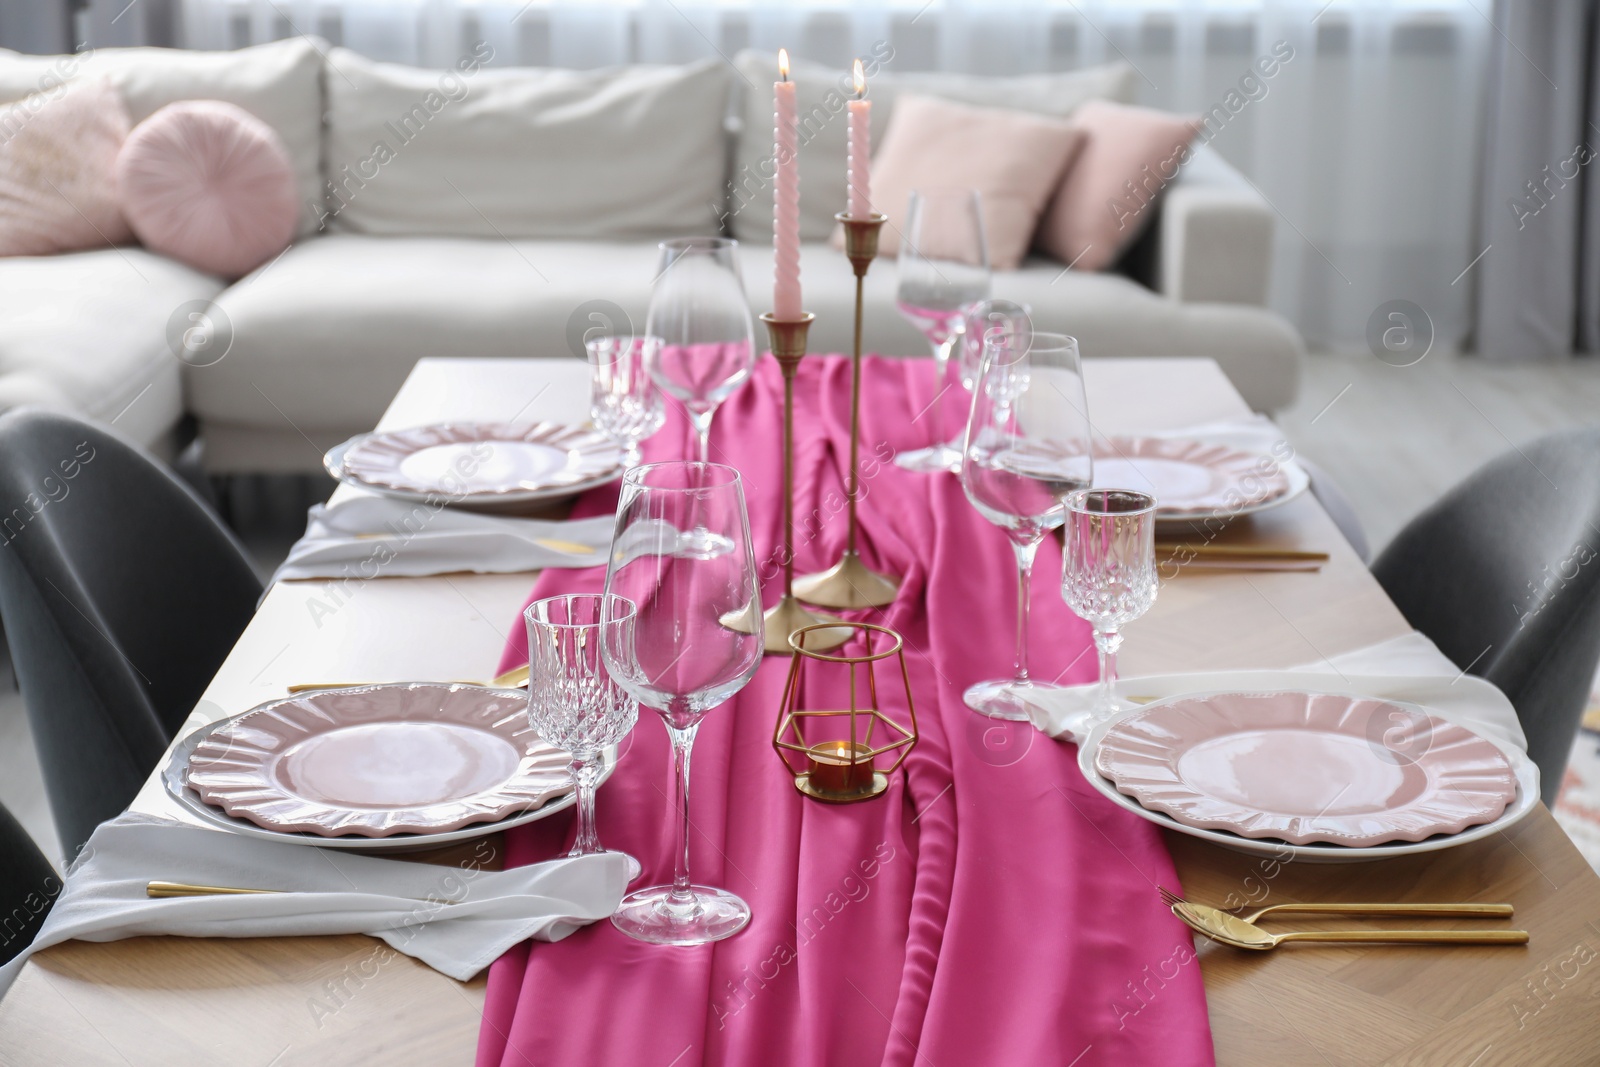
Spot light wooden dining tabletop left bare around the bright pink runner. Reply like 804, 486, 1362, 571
0, 358, 1600, 1067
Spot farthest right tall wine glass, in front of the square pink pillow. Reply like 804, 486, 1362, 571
894, 189, 989, 470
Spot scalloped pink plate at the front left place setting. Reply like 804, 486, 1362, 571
189, 681, 571, 837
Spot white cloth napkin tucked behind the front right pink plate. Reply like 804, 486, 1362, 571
1029, 630, 1528, 752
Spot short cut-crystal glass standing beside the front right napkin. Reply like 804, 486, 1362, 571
1061, 490, 1158, 737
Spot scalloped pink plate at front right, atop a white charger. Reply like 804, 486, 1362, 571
1096, 693, 1517, 846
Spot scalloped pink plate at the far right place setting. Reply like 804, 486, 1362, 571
1094, 437, 1290, 518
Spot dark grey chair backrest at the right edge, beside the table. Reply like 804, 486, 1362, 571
1373, 429, 1600, 805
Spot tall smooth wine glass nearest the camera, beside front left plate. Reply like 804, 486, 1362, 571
602, 462, 765, 945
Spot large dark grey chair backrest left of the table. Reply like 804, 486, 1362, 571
0, 410, 261, 857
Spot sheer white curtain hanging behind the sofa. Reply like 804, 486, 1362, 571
172, 0, 1493, 346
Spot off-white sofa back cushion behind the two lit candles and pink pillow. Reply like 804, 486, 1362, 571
726, 51, 1136, 245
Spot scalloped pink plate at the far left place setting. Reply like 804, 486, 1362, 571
342, 422, 622, 499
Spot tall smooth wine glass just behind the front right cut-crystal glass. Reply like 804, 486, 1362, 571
960, 329, 1094, 720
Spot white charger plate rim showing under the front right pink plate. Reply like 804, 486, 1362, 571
1078, 693, 1539, 864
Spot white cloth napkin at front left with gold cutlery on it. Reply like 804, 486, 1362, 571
0, 813, 638, 997
